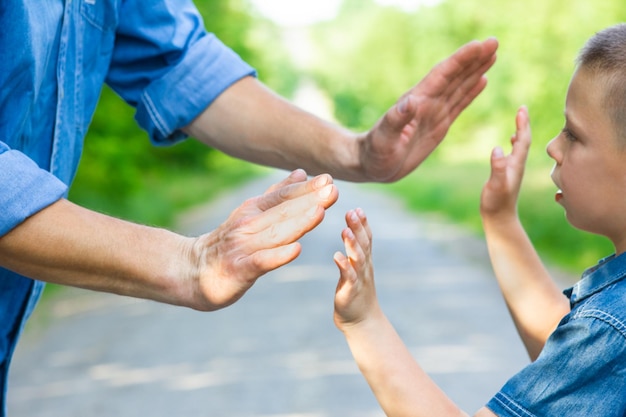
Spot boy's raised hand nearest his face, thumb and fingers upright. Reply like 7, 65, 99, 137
480, 107, 531, 220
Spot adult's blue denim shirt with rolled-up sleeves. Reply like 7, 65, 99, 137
0, 0, 256, 416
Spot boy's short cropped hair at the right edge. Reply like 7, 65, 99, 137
577, 23, 626, 146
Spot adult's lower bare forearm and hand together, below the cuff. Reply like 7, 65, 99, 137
0, 170, 338, 311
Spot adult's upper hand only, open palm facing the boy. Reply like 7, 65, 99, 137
359, 39, 498, 182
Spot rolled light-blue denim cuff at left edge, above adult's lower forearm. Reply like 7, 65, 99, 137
0, 142, 67, 237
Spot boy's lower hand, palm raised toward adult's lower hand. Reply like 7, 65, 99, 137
333, 209, 380, 331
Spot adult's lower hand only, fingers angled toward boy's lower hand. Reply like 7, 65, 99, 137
185, 170, 338, 310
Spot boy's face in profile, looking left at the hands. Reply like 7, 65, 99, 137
547, 68, 626, 253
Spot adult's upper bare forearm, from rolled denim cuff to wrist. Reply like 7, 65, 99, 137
185, 77, 364, 181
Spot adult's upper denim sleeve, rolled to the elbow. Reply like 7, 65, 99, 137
107, 0, 256, 144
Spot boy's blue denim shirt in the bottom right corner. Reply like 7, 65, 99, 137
487, 254, 626, 417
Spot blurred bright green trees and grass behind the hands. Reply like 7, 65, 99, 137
70, 0, 626, 273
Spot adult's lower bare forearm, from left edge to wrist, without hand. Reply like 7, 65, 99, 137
0, 200, 191, 305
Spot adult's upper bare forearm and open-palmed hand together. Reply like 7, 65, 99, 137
185, 39, 498, 182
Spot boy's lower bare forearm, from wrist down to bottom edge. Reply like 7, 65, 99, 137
343, 313, 467, 417
